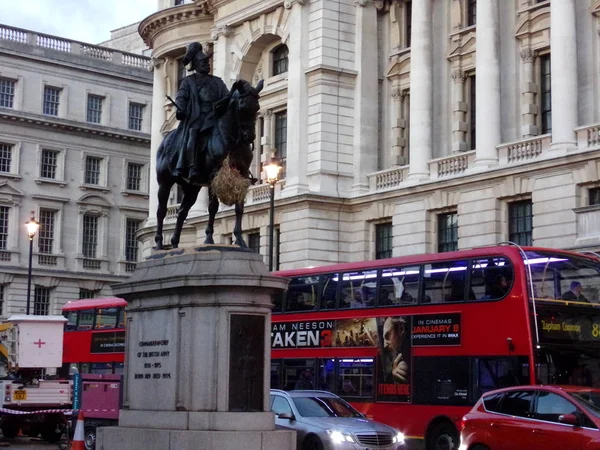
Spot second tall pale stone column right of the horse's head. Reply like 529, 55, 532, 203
352, 0, 379, 192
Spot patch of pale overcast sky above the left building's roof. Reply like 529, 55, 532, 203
0, 0, 157, 44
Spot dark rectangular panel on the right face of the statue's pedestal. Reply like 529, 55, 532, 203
229, 314, 265, 411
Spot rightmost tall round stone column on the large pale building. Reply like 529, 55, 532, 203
550, 0, 578, 151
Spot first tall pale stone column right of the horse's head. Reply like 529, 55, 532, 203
282, 0, 309, 196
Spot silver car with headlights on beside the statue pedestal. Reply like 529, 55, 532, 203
271, 389, 405, 450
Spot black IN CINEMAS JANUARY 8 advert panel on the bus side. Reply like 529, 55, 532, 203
412, 313, 461, 347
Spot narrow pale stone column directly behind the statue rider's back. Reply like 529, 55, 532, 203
146, 58, 167, 226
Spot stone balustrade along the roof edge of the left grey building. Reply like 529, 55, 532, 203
0, 25, 150, 69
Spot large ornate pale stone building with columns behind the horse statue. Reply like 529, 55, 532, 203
139, 0, 600, 269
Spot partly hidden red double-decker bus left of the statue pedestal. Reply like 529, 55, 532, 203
62, 297, 127, 376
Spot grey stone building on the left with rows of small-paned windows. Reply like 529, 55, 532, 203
0, 25, 152, 317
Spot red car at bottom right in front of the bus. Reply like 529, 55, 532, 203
459, 386, 600, 450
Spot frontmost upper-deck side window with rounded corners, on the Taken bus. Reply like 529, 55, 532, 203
471, 258, 514, 300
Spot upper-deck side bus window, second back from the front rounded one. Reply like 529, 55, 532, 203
423, 261, 471, 303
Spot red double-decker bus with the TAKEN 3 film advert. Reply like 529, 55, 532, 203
271, 244, 600, 450
